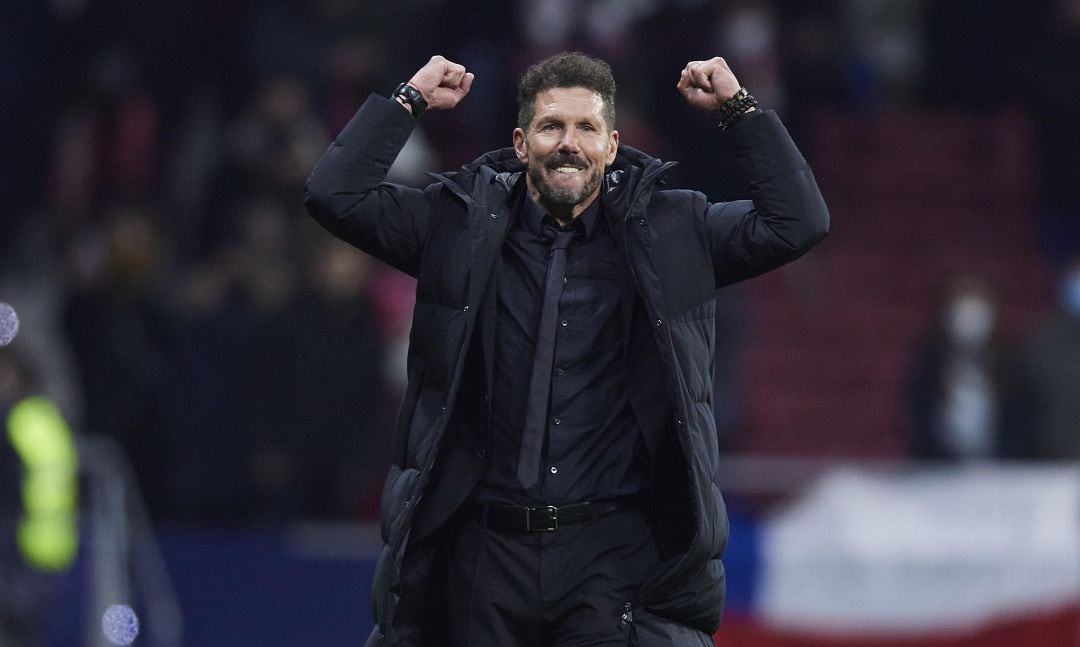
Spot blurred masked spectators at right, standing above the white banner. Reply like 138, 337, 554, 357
908, 265, 1080, 461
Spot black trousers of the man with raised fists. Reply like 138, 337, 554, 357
440, 510, 713, 647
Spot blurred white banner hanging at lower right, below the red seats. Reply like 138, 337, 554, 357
758, 464, 1080, 634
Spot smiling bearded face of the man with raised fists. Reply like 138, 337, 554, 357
514, 87, 619, 211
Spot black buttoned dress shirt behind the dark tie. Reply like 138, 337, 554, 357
476, 180, 646, 506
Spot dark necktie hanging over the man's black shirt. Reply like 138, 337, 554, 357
517, 225, 575, 489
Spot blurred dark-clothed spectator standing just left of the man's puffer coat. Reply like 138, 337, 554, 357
285, 233, 390, 520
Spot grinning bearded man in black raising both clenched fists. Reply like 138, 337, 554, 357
307, 54, 828, 647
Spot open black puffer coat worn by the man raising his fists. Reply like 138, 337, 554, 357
307, 97, 828, 645
